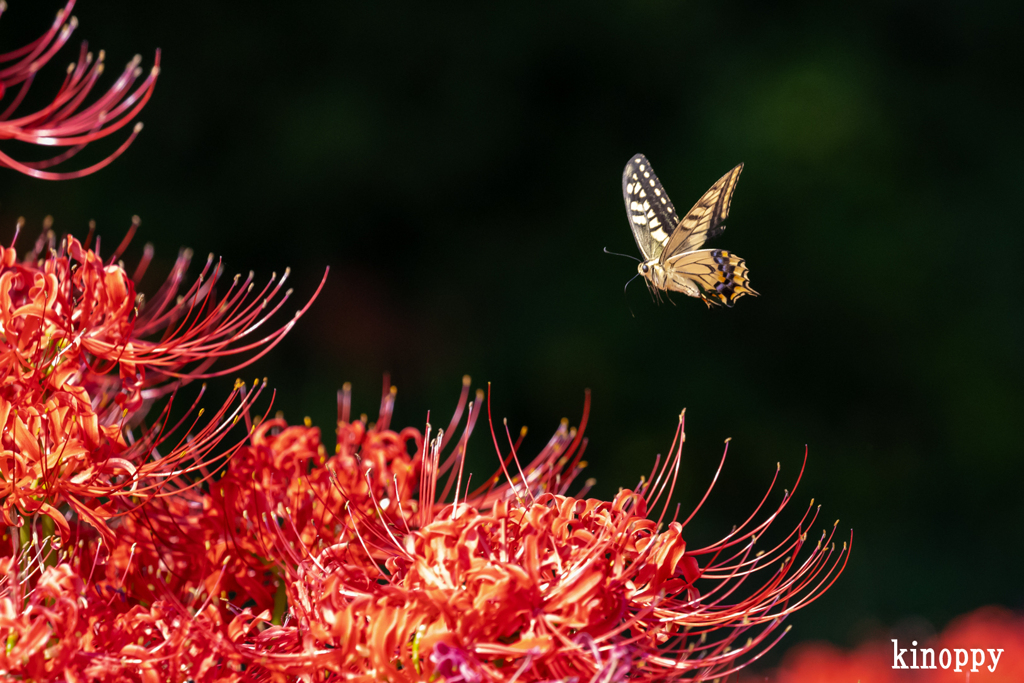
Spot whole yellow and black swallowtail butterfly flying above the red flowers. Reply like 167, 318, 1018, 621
623, 155, 758, 307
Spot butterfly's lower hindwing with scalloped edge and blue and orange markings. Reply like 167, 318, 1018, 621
665, 249, 758, 308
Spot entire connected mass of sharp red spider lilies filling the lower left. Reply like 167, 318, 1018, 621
0, 238, 848, 683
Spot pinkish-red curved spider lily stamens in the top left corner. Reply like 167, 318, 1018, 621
0, 0, 160, 180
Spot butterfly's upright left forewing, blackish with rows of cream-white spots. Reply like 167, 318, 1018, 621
623, 155, 679, 261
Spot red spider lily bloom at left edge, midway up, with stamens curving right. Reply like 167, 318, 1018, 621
0, 220, 323, 545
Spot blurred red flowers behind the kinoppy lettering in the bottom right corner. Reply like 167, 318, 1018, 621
739, 606, 1024, 683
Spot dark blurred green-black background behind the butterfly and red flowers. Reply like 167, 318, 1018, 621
0, 0, 1024, 663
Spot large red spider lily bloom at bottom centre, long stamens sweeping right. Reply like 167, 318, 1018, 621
263, 384, 847, 682
